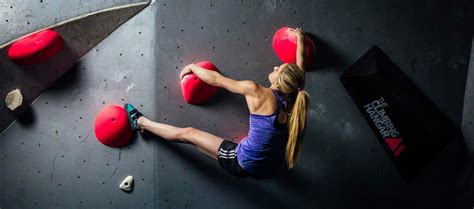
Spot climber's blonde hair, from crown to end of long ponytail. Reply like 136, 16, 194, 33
275, 64, 309, 168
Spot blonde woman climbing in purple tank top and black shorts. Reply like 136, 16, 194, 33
125, 28, 309, 178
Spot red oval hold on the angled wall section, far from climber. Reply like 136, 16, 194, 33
8, 29, 64, 65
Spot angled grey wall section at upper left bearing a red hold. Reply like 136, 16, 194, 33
0, 1, 148, 132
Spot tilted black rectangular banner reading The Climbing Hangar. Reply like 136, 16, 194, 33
340, 46, 462, 179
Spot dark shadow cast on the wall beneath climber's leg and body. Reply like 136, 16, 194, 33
143, 132, 314, 209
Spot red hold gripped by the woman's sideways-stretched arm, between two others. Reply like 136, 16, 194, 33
181, 61, 219, 104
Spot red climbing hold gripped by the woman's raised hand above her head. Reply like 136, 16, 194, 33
272, 27, 316, 66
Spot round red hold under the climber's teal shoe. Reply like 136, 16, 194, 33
95, 105, 133, 147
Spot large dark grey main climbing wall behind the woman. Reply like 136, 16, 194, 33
0, 0, 474, 209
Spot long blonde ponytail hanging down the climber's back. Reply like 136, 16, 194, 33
286, 90, 309, 168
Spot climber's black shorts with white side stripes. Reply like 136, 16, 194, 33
217, 140, 248, 177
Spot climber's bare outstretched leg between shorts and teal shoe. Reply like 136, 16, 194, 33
138, 116, 224, 160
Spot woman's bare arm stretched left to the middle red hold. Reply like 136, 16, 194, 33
180, 64, 260, 96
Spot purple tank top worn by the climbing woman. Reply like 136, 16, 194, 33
236, 89, 288, 178
